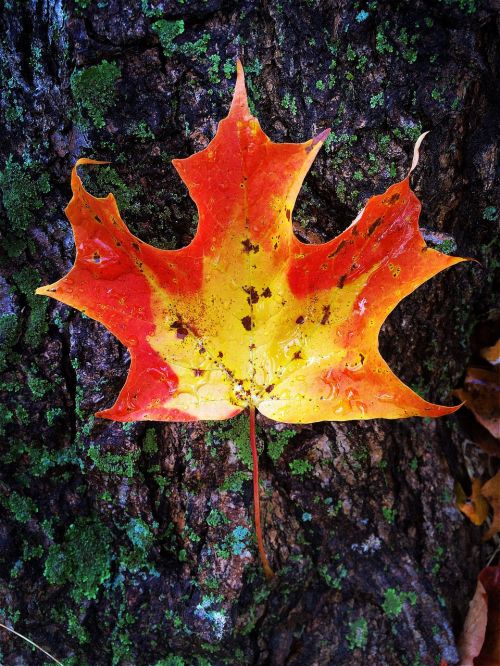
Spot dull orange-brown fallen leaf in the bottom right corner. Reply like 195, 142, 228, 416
458, 566, 500, 666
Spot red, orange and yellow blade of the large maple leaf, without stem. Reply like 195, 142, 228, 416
37, 63, 462, 423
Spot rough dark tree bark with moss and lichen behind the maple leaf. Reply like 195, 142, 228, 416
0, 0, 499, 666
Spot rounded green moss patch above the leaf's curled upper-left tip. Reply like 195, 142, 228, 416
70, 60, 121, 127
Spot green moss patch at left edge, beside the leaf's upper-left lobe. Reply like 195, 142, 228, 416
0, 155, 50, 257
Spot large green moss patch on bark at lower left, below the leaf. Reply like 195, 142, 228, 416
44, 517, 112, 602
